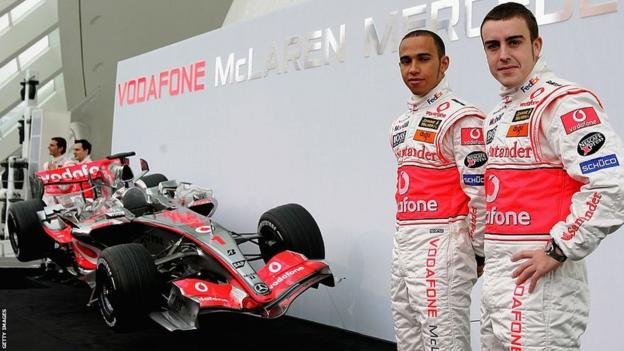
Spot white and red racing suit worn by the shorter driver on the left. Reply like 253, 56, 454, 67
390, 79, 486, 351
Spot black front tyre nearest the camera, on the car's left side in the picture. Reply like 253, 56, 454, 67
95, 244, 160, 332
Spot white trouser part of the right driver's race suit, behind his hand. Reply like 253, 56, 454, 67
481, 245, 589, 351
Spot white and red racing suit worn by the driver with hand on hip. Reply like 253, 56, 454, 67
481, 59, 624, 351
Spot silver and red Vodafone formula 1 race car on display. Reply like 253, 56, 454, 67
8, 152, 334, 331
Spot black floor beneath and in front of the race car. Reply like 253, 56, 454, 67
0, 268, 396, 351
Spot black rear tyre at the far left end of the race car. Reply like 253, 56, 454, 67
8, 199, 54, 262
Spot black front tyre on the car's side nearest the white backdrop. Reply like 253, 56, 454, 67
258, 204, 325, 262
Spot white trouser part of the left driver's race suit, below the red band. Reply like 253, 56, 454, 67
391, 220, 477, 351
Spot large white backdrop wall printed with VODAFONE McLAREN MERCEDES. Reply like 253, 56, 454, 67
112, 0, 624, 350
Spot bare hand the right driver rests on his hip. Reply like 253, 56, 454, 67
511, 249, 561, 293
